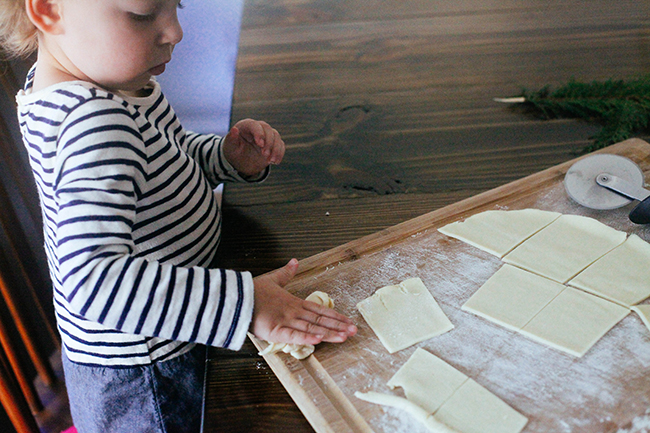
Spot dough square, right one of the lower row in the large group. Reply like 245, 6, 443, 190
520, 287, 630, 357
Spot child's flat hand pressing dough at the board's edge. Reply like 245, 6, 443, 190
251, 259, 357, 345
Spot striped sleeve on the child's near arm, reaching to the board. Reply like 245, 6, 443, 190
50, 100, 254, 349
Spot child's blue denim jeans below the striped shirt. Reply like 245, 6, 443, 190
62, 346, 206, 433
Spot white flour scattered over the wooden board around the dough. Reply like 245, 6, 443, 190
288, 184, 650, 433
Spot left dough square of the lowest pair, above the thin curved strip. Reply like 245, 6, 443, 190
387, 348, 468, 413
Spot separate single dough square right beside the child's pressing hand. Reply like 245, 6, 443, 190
357, 278, 454, 353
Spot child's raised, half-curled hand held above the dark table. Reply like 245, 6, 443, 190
223, 119, 284, 177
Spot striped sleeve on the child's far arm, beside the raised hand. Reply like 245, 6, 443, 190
183, 132, 270, 187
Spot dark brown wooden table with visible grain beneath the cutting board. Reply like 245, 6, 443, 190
204, 0, 650, 432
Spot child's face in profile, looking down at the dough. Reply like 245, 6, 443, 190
56, 0, 183, 91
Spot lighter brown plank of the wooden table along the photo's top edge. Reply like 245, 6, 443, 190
230, 1, 648, 103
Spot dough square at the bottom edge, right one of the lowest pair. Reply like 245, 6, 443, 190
433, 379, 528, 433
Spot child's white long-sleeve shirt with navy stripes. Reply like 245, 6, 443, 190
17, 70, 262, 367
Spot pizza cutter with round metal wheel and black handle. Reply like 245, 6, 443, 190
564, 154, 650, 224
